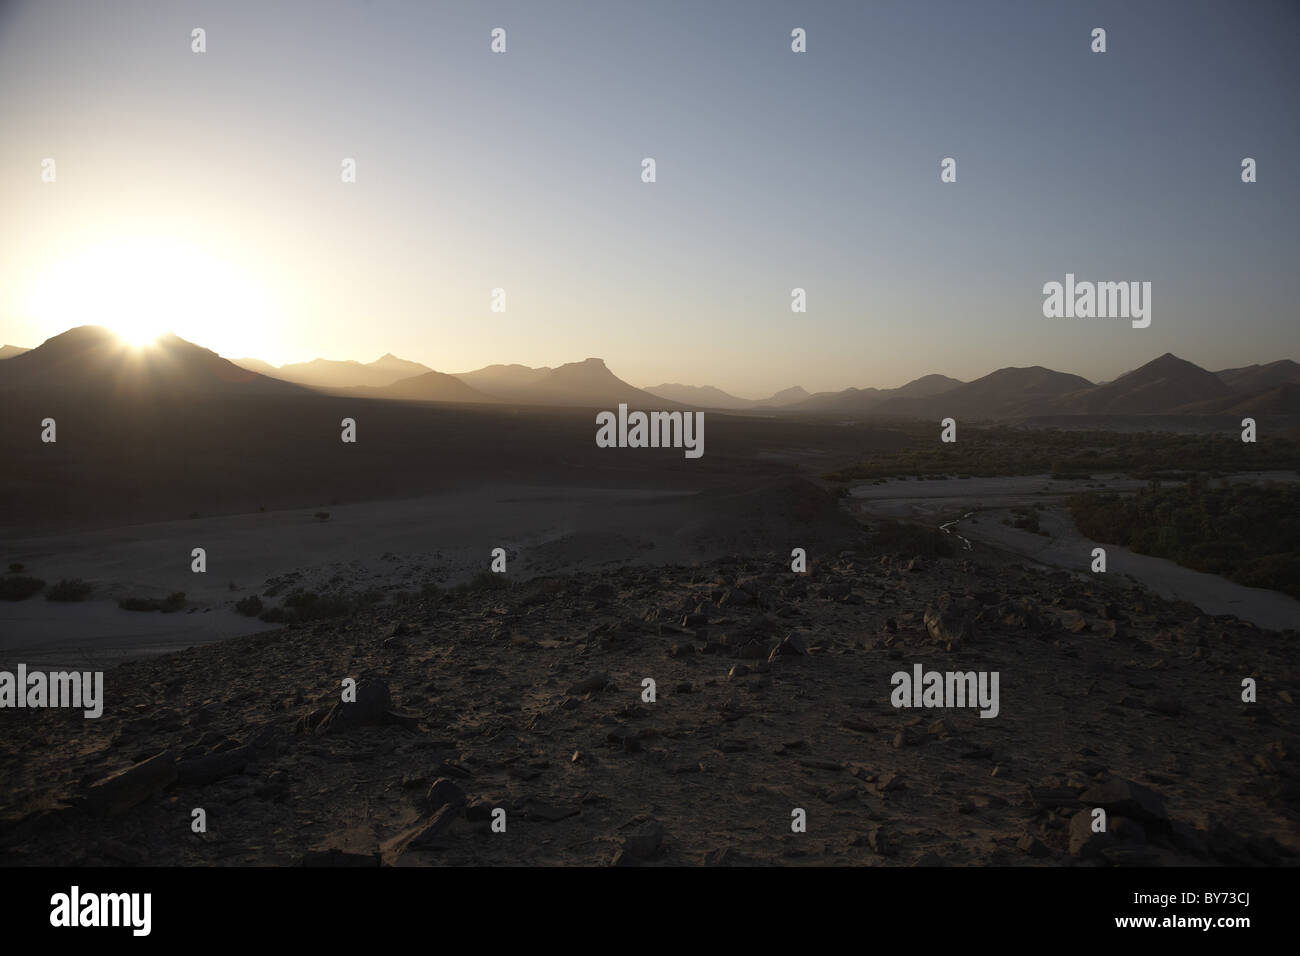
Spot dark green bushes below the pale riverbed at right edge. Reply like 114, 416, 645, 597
1069, 476, 1300, 597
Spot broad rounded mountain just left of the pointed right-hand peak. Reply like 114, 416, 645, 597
872, 365, 1092, 419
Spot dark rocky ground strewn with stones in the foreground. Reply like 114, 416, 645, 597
0, 535, 1300, 866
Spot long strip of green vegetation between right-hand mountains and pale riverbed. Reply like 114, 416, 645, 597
823, 423, 1300, 481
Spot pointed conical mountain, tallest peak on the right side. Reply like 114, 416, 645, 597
1045, 352, 1230, 415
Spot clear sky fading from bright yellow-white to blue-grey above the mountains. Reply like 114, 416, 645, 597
0, 0, 1300, 397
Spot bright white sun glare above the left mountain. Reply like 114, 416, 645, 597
27, 238, 269, 355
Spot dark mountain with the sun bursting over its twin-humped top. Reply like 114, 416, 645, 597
0, 325, 299, 398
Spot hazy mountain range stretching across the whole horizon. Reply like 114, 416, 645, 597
0, 325, 1300, 420
